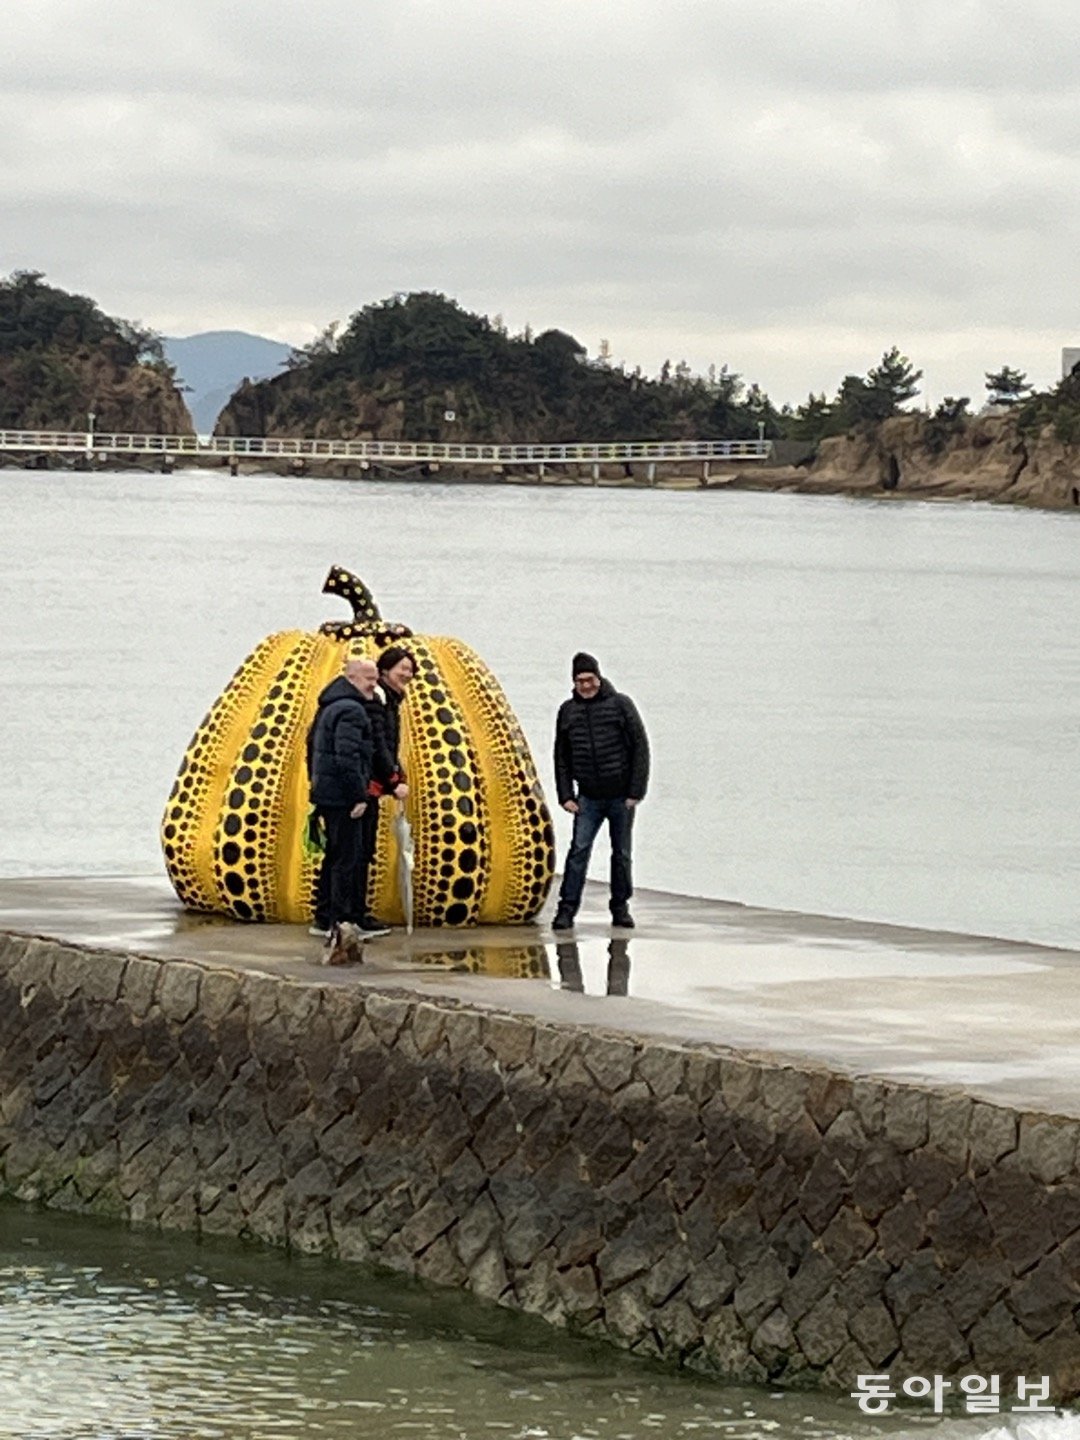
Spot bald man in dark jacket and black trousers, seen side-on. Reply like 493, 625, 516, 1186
307, 660, 379, 953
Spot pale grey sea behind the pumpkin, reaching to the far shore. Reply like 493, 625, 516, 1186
0, 471, 1080, 945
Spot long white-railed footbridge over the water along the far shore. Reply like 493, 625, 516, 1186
0, 431, 772, 477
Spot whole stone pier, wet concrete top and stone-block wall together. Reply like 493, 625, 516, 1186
0, 880, 1080, 1401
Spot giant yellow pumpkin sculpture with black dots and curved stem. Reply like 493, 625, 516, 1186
161, 566, 554, 926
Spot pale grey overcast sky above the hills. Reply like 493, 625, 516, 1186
0, 0, 1080, 403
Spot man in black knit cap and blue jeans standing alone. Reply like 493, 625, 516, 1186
553, 651, 649, 930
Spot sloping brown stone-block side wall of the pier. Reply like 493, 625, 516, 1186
0, 935, 1080, 1398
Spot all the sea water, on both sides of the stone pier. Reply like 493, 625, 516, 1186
0, 471, 1080, 1440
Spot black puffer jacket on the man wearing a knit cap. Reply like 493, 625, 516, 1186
554, 680, 649, 805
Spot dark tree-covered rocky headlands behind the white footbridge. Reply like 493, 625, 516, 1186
0, 271, 1080, 505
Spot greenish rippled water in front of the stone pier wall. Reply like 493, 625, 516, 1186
0, 1205, 1080, 1440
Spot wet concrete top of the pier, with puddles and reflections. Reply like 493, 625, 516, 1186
0, 877, 1080, 1116
